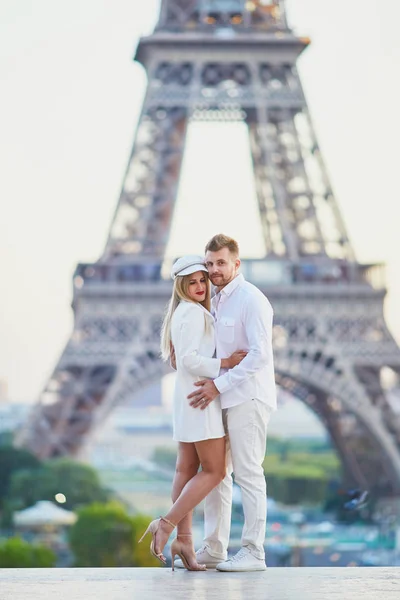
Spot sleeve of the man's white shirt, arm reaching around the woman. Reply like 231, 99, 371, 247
214, 297, 273, 394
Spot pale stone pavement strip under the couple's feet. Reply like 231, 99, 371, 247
0, 567, 400, 600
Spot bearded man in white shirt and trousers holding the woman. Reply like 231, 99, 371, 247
175, 234, 276, 571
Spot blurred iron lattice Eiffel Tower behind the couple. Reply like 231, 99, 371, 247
17, 0, 400, 496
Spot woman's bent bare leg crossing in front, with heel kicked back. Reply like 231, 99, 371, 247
156, 438, 226, 552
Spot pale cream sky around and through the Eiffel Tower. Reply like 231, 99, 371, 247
0, 0, 400, 402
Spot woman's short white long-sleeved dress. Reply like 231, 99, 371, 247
171, 301, 225, 442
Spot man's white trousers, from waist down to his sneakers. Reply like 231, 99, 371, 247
204, 399, 271, 560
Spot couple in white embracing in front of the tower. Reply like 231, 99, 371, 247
140, 234, 276, 571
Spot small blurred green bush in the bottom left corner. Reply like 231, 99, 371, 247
0, 537, 57, 569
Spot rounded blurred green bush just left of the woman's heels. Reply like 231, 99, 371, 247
69, 502, 160, 567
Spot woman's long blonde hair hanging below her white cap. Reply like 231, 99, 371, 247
160, 271, 211, 361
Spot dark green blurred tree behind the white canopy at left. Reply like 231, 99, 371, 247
7, 458, 111, 510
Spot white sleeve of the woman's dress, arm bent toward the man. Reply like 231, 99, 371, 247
175, 307, 221, 379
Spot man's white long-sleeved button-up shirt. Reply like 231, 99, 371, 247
212, 275, 276, 410
